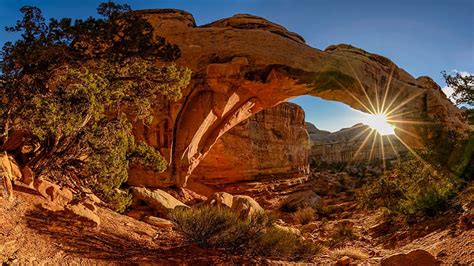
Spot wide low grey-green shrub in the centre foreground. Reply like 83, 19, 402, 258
169, 206, 319, 260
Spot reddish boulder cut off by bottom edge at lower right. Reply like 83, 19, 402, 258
381, 249, 436, 266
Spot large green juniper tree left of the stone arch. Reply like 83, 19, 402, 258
0, 2, 190, 210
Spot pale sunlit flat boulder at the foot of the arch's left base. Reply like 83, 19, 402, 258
131, 187, 189, 216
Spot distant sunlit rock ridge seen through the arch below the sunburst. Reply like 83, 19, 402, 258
306, 123, 407, 163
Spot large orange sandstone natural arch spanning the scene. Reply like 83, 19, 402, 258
129, 10, 465, 187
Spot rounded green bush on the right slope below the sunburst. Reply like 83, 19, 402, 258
358, 152, 459, 221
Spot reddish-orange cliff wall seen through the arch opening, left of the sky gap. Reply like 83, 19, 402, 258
189, 103, 310, 195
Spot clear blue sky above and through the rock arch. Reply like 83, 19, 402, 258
0, 0, 474, 131
